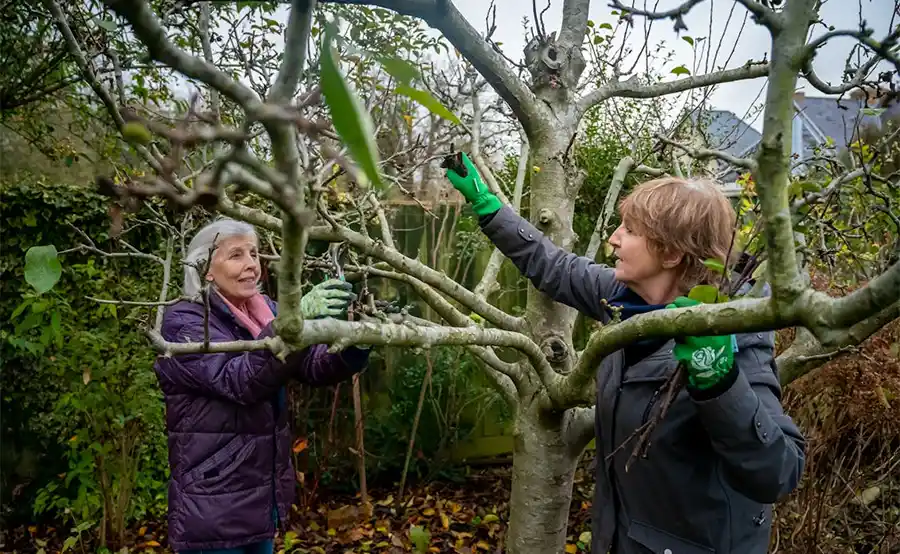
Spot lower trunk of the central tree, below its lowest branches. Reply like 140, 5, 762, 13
506, 403, 578, 554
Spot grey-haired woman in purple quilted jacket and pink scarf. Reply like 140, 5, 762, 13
155, 219, 369, 554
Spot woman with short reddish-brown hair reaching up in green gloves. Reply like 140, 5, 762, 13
447, 155, 804, 554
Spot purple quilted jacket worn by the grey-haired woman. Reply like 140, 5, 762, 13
155, 294, 368, 551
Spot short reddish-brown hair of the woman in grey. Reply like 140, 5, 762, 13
619, 177, 737, 291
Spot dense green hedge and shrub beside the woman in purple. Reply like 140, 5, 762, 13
0, 178, 167, 536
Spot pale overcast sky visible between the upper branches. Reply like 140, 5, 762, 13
442, 0, 896, 128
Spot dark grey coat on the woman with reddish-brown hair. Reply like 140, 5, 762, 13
482, 207, 804, 554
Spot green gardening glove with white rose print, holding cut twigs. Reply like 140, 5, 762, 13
666, 296, 734, 390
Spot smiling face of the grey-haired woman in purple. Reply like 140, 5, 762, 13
206, 236, 260, 302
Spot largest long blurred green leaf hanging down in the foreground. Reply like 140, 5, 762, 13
321, 26, 383, 188
